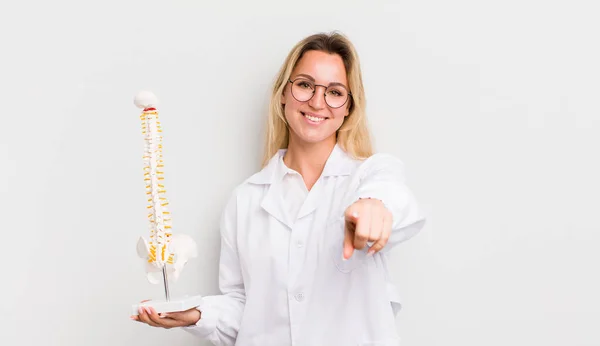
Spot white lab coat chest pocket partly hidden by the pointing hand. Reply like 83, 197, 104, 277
327, 217, 367, 273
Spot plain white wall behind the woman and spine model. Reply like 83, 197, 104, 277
0, 0, 600, 346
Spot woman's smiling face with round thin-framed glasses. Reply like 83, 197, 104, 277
281, 51, 350, 145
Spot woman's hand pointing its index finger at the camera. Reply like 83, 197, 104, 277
344, 198, 392, 259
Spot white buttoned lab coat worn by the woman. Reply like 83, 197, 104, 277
184, 145, 425, 346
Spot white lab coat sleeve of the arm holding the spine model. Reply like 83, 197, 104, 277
183, 196, 246, 346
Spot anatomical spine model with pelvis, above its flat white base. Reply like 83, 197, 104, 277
134, 91, 197, 290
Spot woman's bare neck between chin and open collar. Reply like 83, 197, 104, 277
283, 136, 336, 190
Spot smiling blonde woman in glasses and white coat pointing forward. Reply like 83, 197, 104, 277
132, 33, 424, 346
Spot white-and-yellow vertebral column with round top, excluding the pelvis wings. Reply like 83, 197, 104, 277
135, 92, 173, 268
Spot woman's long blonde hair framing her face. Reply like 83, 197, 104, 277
262, 32, 373, 166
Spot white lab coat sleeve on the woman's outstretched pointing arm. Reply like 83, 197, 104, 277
353, 154, 425, 252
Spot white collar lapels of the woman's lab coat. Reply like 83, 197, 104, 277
248, 143, 353, 185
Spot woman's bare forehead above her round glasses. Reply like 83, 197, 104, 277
292, 51, 347, 85
